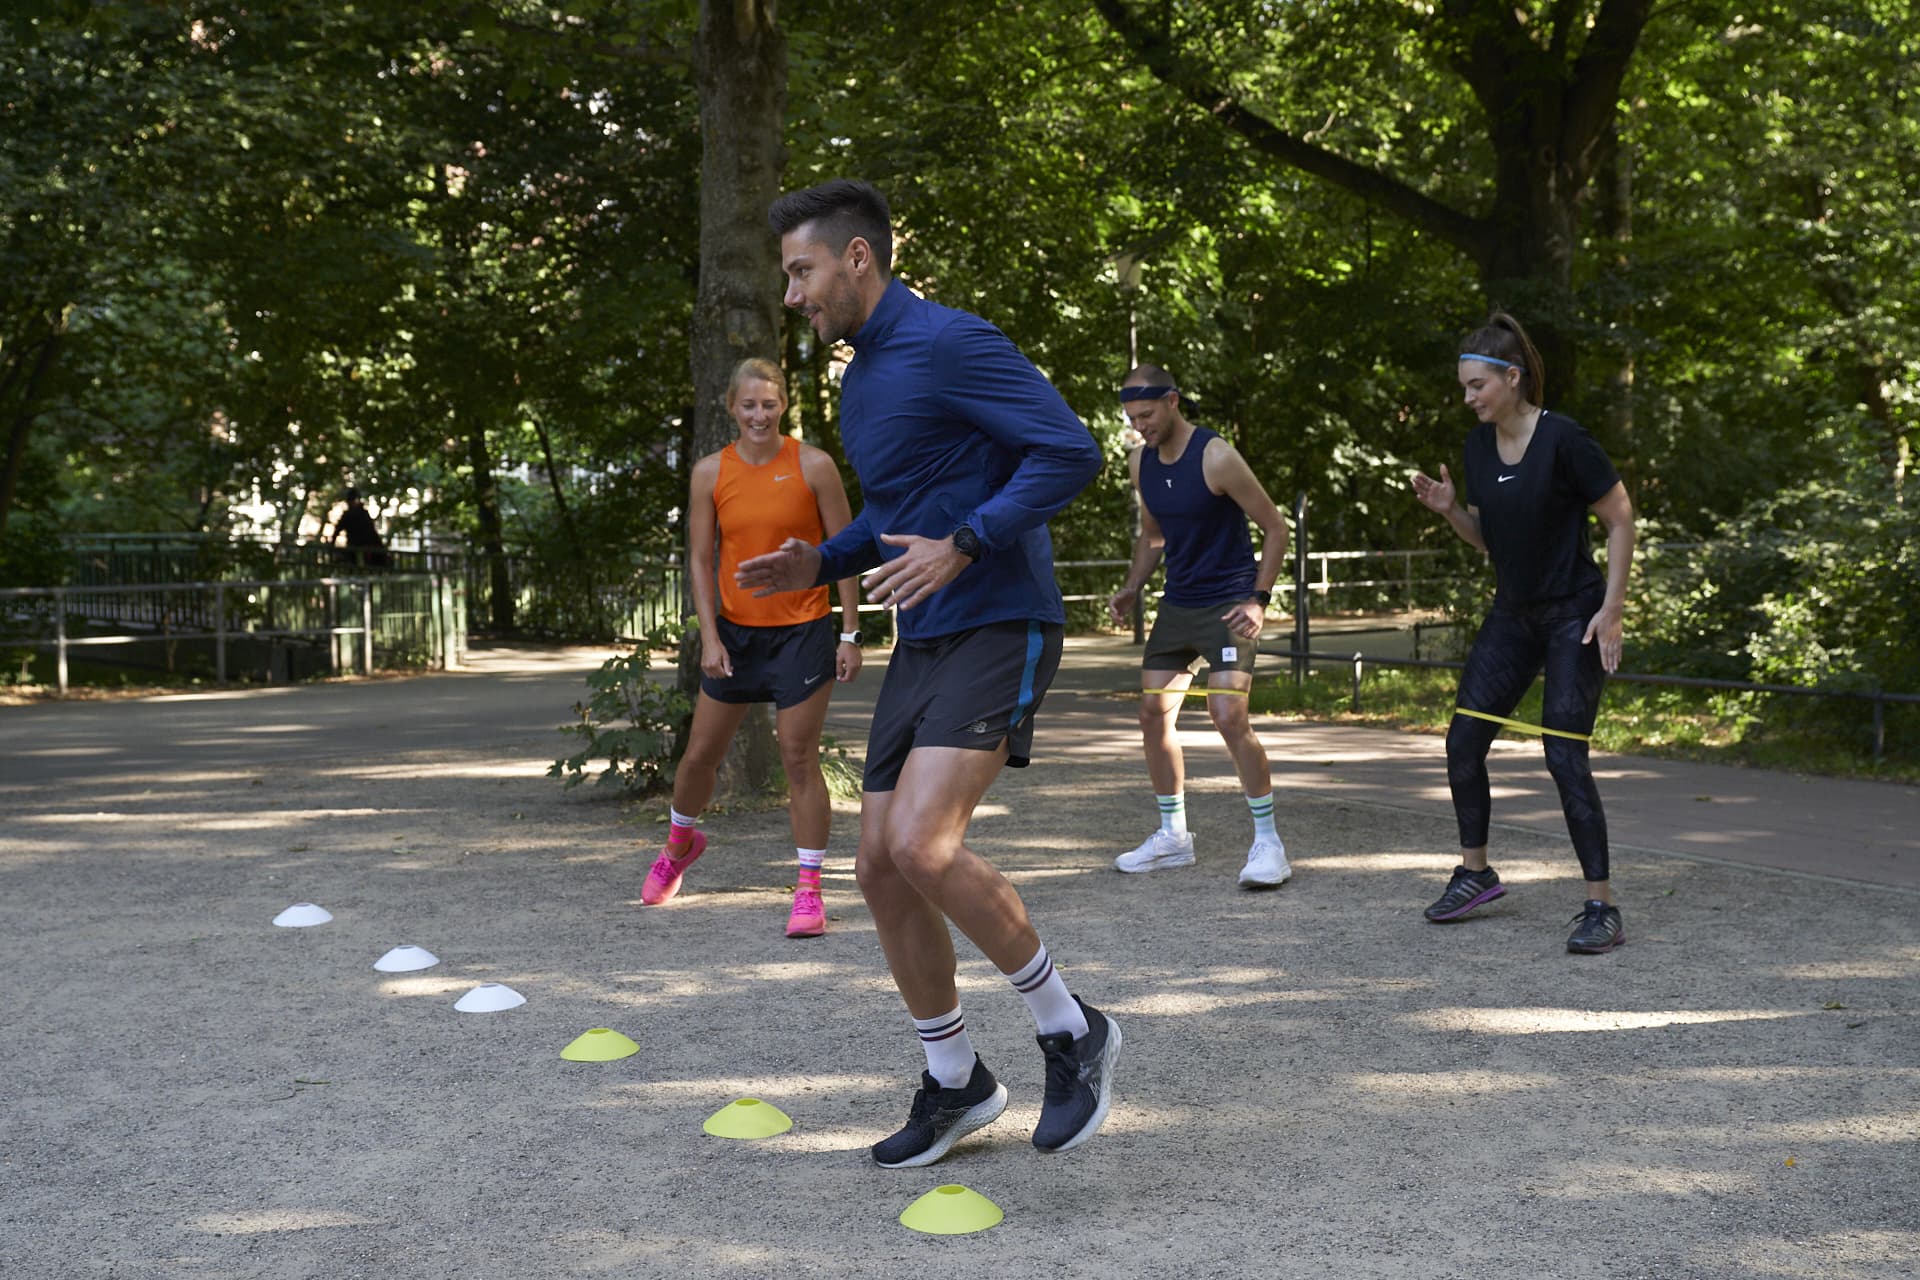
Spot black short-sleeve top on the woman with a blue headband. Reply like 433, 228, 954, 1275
1461, 411, 1620, 604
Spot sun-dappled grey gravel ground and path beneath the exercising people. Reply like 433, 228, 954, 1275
0, 641, 1920, 1280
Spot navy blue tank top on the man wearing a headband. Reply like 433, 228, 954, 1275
1140, 426, 1254, 608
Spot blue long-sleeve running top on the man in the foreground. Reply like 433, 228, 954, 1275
820, 280, 1100, 641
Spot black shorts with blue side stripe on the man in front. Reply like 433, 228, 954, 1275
860, 622, 1064, 791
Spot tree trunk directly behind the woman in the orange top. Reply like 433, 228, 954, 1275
680, 0, 787, 793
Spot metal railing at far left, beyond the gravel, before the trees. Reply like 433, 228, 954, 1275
0, 574, 467, 697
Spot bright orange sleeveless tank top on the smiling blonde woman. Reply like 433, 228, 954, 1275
714, 436, 831, 628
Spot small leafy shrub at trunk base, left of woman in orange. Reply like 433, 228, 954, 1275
547, 629, 689, 794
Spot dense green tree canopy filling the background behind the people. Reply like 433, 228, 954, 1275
0, 0, 1920, 690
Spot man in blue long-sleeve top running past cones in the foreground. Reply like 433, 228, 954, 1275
739, 180, 1121, 1169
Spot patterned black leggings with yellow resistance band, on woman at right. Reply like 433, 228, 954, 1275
1446, 591, 1607, 881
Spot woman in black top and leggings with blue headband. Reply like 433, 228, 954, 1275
1413, 311, 1634, 954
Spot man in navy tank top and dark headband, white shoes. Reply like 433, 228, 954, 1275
1108, 365, 1292, 889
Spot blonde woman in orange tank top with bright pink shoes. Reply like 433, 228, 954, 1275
639, 359, 860, 938
